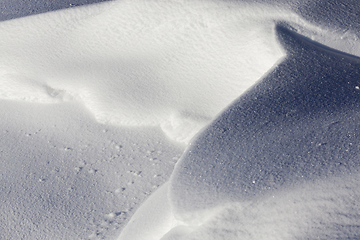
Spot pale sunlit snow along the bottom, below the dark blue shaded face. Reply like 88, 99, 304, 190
118, 175, 360, 240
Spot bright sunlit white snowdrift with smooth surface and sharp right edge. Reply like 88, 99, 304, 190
0, 0, 357, 142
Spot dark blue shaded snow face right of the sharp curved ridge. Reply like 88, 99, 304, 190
164, 25, 360, 236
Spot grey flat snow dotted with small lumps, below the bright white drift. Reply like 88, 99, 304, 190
0, 100, 184, 240
